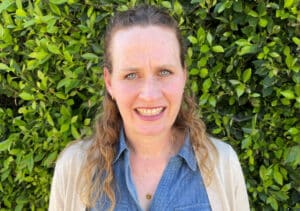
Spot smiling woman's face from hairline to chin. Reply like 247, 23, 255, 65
104, 26, 186, 136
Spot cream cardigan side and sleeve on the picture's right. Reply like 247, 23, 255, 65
207, 138, 250, 211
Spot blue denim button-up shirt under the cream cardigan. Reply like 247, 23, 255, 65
91, 130, 211, 211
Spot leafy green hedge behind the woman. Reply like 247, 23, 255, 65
0, 0, 300, 210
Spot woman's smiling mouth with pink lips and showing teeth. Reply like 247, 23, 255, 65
134, 106, 166, 121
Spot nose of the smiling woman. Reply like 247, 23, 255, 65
139, 77, 162, 102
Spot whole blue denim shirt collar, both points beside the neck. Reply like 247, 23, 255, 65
113, 128, 197, 171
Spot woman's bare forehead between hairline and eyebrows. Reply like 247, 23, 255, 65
111, 26, 180, 66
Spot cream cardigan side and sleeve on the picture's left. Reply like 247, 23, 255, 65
48, 142, 85, 211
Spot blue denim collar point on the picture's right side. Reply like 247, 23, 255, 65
178, 133, 197, 171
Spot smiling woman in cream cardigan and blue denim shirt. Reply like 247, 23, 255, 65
49, 3, 249, 211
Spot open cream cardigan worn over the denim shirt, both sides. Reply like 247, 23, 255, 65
49, 138, 250, 211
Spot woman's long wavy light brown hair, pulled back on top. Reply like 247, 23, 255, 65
79, 5, 217, 210
